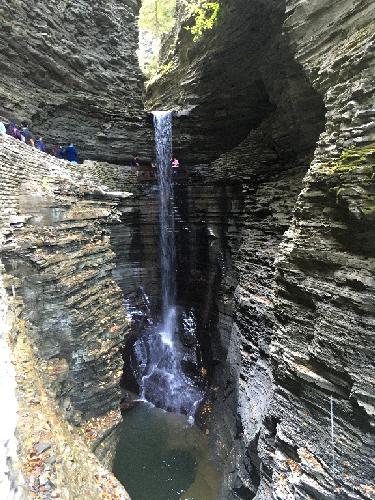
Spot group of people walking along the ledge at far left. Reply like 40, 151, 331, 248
0, 121, 78, 164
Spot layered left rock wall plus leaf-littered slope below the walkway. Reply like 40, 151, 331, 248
0, 136, 128, 498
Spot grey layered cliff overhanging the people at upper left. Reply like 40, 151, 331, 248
0, 0, 152, 164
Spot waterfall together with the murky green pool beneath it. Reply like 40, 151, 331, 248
113, 112, 220, 500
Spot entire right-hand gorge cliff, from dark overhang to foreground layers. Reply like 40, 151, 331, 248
148, 1, 375, 499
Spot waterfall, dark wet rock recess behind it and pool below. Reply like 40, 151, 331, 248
112, 113, 245, 500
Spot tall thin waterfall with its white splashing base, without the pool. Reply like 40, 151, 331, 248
134, 112, 203, 419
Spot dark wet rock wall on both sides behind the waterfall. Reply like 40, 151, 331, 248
111, 178, 242, 421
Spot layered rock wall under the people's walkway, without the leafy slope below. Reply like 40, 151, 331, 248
0, 137, 126, 423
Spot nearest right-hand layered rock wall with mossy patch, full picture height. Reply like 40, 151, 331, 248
259, 1, 375, 499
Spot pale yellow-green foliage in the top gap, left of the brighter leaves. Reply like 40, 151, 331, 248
139, 0, 176, 37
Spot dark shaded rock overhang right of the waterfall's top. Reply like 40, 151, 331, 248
146, 0, 324, 164
